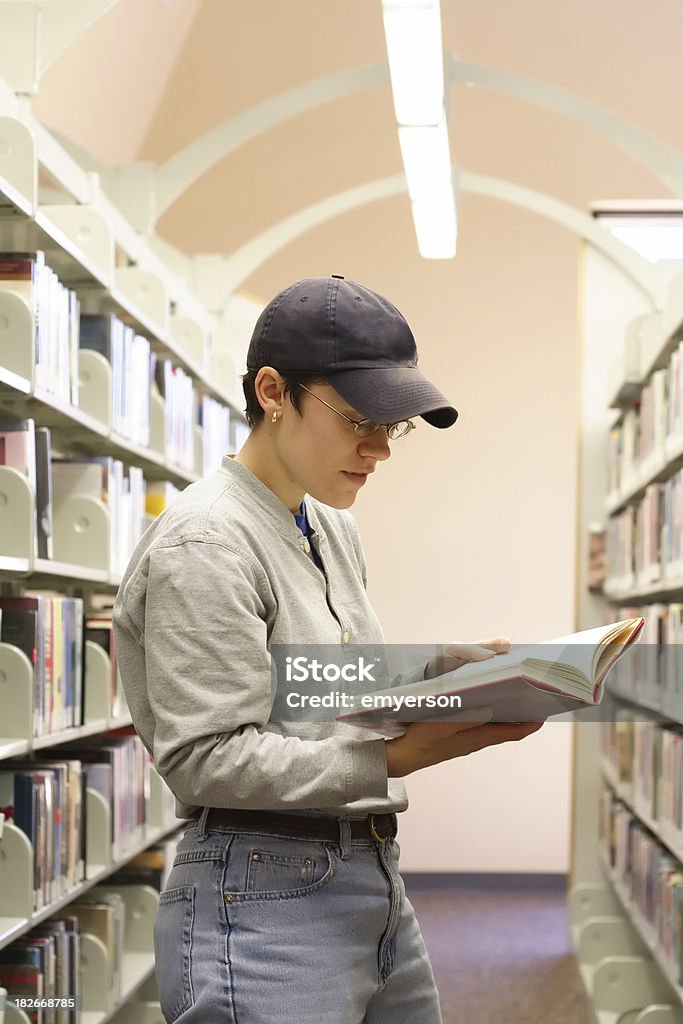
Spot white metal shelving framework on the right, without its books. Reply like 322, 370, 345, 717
569, 246, 683, 1024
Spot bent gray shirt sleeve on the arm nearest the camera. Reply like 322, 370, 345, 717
127, 541, 387, 810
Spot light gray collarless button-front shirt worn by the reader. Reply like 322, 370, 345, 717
114, 457, 408, 817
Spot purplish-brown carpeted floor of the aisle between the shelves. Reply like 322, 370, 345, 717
407, 878, 594, 1024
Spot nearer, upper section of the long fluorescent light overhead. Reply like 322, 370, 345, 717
382, 0, 443, 125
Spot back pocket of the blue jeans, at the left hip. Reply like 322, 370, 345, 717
155, 886, 195, 1024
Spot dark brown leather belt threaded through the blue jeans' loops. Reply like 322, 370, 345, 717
200, 807, 398, 843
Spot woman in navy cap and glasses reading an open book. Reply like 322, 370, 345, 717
115, 275, 539, 1024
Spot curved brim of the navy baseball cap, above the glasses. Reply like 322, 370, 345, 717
328, 367, 458, 428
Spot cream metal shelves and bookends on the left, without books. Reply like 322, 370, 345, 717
0, 94, 244, 1024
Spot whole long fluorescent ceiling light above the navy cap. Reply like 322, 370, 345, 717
382, 0, 457, 259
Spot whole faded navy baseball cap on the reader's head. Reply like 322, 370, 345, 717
247, 273, 458, 427
